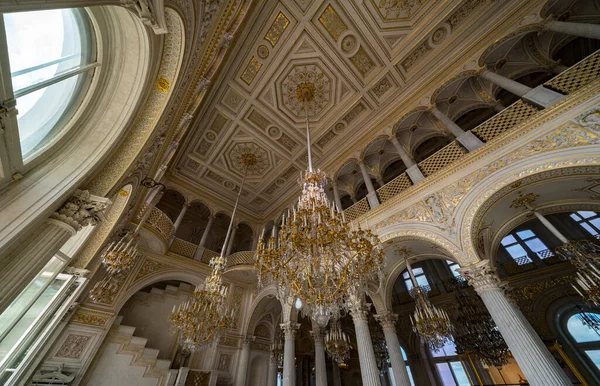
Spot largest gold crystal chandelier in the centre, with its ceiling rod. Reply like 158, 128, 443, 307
255, 82, 383, 327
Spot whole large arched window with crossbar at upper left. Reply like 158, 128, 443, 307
4, 9, 95, 159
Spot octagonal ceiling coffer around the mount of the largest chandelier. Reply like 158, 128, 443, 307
281, 63, 332, 119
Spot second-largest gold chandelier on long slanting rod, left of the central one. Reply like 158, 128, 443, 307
171, 153, 256, 351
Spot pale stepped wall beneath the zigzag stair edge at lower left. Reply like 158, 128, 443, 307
86, 343, 159, 386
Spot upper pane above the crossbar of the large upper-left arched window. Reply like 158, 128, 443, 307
4, 10, 83, 92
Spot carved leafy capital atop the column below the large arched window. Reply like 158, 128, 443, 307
50, 189, 110, 231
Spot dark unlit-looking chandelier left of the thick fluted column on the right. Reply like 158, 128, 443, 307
453, 278, 511, 367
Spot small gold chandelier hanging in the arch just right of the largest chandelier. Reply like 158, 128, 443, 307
406, 261, 454, 351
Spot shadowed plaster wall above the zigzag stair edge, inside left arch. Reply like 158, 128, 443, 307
121, 285, 191, 360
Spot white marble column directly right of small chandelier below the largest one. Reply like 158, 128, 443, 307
350, 304, 381, 386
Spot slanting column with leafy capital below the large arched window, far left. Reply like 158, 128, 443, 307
0, 189, 110, 314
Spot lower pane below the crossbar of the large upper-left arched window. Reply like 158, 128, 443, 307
17, 75, 83, 157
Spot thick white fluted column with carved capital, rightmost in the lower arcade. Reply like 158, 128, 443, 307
458, 260, 571, 386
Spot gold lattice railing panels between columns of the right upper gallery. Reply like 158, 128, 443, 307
344, 51, 600, 221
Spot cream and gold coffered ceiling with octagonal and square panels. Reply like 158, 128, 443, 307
169, 0, 537, 222
